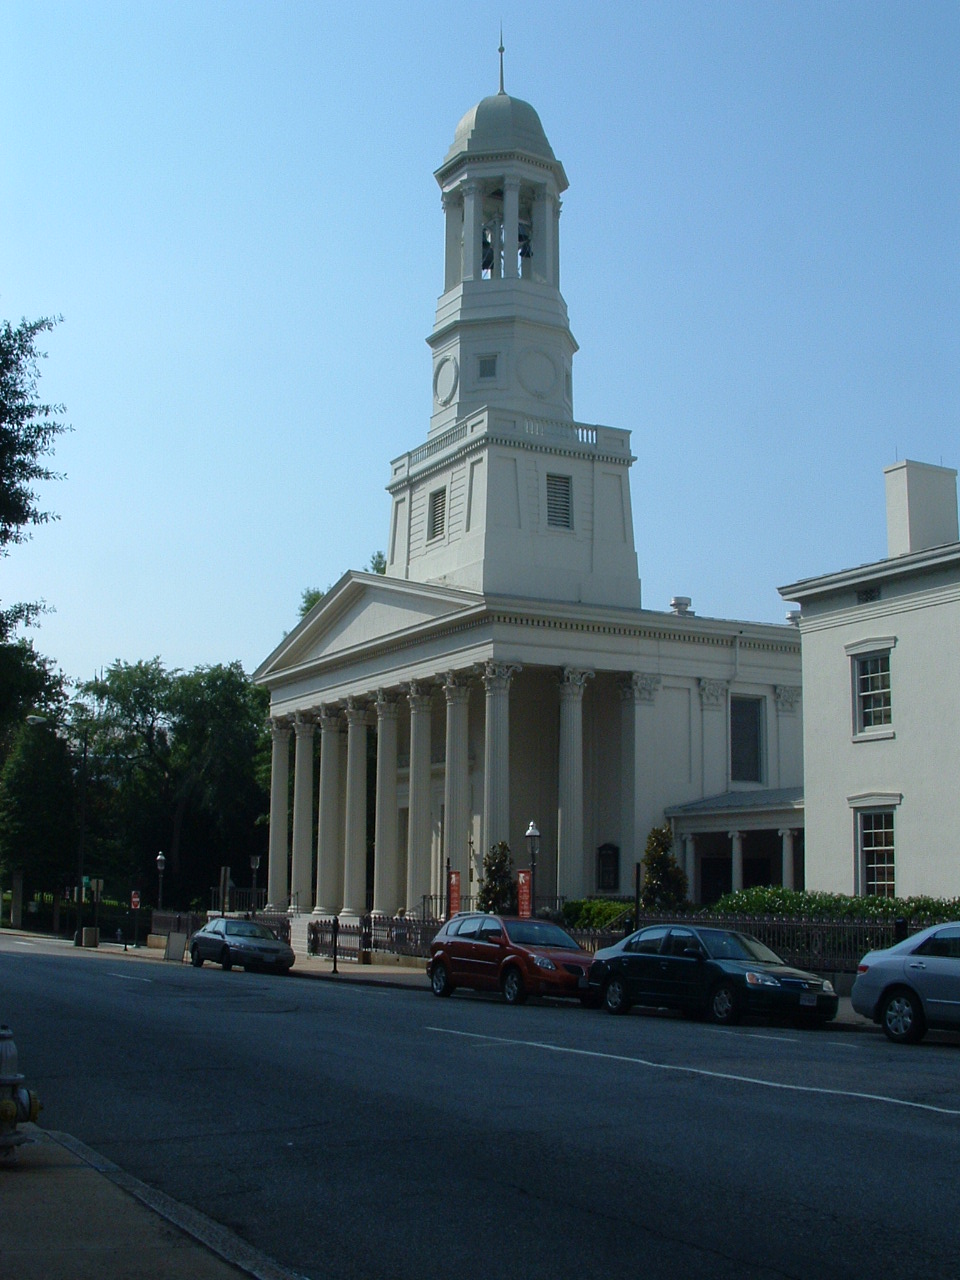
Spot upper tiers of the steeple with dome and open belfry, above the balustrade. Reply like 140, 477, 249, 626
428, 61, 577, 435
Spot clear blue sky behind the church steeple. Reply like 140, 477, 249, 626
0, 0, 960, 678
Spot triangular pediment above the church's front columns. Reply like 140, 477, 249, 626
253, 571, 484, 682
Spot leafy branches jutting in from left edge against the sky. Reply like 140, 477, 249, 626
0, 316, 67, 640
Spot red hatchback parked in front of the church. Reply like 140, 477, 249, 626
426, 911, 593, 1005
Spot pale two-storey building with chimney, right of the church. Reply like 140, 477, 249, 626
781, 462, 960, 897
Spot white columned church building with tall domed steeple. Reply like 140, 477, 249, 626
255, 77, 804, 919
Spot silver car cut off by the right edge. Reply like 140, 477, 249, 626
850, 922, 960, 1044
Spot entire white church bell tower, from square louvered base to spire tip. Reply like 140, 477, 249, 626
387, 62, 640, 608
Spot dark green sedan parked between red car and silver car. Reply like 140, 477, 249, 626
588, 924, 838, 1025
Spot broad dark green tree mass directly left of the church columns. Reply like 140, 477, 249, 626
72, 658, 270, 906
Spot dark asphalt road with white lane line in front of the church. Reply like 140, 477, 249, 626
0, 940, 960, 1280
